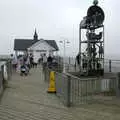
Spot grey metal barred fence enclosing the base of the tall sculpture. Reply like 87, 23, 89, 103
45, 66, 120, 106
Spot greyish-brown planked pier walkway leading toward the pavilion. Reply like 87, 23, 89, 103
0, 67, 120, 120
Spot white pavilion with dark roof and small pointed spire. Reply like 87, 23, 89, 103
14, 30, 59, 60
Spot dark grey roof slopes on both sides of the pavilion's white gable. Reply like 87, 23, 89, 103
14, 39, 59, 51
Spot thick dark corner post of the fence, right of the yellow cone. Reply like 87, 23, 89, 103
66, 75, 71, 107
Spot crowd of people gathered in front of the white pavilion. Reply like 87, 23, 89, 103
11, 54, 55, 75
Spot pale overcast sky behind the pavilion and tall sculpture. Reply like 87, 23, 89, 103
0, 0, 120, 58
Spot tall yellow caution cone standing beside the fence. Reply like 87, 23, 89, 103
47, 71, 56, 93
